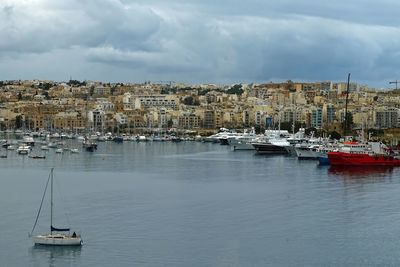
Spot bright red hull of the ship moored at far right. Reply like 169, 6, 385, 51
328, 152, 400, 166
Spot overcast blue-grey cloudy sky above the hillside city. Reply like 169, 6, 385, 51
0, 0, 400, 88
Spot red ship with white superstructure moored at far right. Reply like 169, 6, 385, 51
327, 142, 400, 166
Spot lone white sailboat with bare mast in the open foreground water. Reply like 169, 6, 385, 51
29, 168, 82, 246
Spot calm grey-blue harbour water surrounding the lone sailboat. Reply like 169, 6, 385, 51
0, 142, 400, 267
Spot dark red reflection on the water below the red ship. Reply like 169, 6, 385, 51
328, 166, 393, 178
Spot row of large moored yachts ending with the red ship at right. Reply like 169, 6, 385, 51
206, 128, 400, 166
